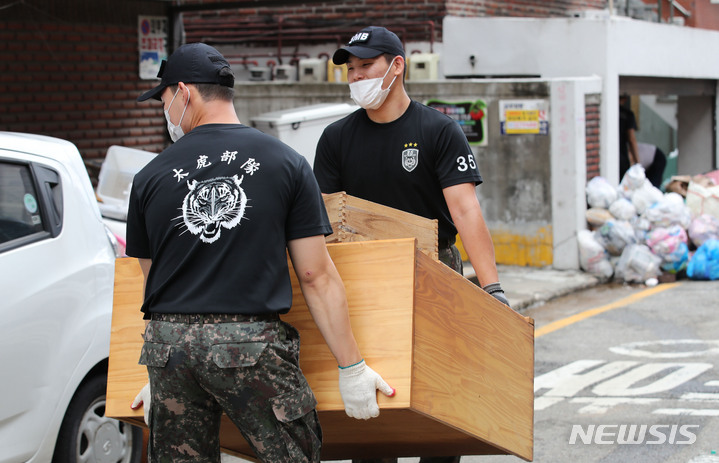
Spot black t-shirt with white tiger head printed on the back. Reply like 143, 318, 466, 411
126, 124, 332, 317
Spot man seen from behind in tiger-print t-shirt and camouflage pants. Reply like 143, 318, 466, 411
127, 43, 394, 463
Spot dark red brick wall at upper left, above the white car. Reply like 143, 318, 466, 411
0, 0, 168, 174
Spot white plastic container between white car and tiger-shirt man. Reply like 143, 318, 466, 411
95, 145, 157, 220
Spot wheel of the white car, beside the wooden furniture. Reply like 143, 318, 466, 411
52, 376, 143, 463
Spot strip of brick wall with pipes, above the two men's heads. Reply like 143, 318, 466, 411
179, 0, 607, 46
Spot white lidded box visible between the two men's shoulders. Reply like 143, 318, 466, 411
250, 103, 359, 165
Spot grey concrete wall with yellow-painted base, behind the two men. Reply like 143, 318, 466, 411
235, 78, 601, 269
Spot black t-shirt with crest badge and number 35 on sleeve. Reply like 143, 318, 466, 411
314, 101, 482, 242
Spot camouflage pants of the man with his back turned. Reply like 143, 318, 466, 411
140, 315, 322, 463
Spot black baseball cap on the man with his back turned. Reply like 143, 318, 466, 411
137, 42, 235, 101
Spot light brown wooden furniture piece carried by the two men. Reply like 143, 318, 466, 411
106, 238, 534, 460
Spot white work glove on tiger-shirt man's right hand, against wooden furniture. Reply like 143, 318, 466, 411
339, 359, 395, 420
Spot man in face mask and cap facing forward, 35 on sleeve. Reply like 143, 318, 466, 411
314, 26, 507, 463
